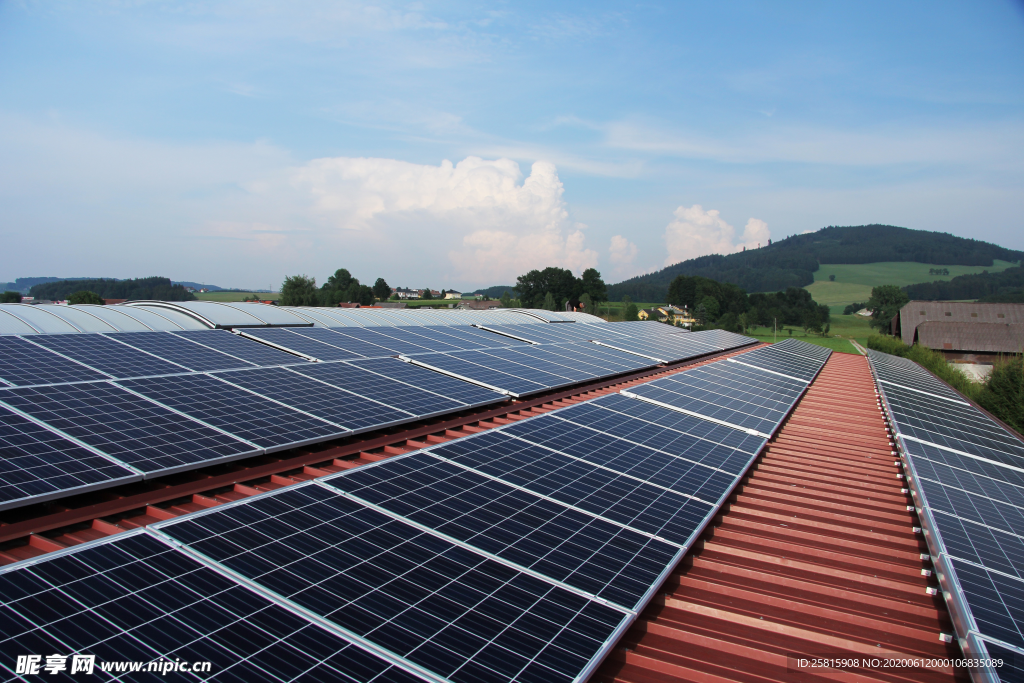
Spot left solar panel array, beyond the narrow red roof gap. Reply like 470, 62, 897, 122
0, 325, 746, 509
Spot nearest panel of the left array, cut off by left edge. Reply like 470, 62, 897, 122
0, 403, 141, 509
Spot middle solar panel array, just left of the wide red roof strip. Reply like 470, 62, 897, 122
0, 337, 827, 681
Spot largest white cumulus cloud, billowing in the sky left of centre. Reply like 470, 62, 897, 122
291, 157, 598, 284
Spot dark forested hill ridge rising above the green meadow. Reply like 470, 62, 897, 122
608, 224, 1024, 301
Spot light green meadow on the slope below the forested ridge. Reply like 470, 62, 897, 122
804, 261, 1017, 305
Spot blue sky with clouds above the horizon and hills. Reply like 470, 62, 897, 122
0, 0, 1024, 289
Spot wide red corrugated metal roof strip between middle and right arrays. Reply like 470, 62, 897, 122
592, 353, 969, 683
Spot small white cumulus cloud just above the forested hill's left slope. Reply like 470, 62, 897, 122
665, 204, 771, 265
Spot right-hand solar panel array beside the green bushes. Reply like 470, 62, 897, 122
868, 350, 1024, 681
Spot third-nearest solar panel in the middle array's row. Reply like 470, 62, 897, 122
325, 453, 680, 609
